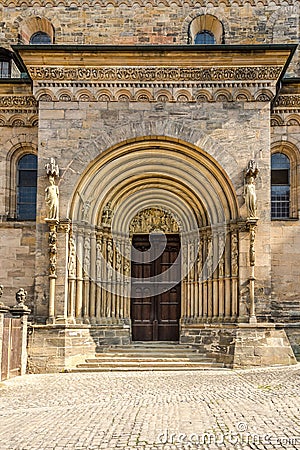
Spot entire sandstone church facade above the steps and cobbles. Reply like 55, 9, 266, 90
0, 0, 300, 372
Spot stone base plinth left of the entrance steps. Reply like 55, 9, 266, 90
27, 324, 130, 373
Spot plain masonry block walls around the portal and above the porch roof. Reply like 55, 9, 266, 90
0, 0, 300, 326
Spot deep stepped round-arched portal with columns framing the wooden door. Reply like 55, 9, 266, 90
68, 137, 239, 342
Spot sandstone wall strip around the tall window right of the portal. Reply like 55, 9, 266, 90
271, 100, 300, 322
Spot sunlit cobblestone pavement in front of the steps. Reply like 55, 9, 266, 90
0, 365, 300, 450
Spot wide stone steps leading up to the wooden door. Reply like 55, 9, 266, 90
68, 342, 224, 372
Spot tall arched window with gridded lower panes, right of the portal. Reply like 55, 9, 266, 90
271, 153, 290, 219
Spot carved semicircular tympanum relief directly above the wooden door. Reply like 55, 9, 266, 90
129, 208, 180, 234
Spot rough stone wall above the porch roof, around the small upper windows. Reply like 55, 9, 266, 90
0, 0, 300, 73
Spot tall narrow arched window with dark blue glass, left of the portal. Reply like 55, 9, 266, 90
17, 154, 37, 220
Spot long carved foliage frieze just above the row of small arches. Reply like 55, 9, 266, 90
29, 66, 282, 82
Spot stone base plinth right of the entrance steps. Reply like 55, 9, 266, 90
180, 323, 297, 369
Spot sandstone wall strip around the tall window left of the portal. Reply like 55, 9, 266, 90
0, 123, 37, 312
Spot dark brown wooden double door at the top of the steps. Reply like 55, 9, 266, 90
131, 233, 181, 341
